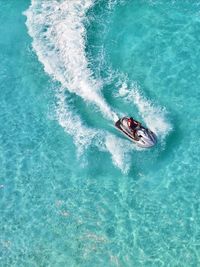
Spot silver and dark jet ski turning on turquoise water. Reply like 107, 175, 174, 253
115, 117, 157, 148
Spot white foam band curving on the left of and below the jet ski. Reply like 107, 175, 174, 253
56, 89, 134, 173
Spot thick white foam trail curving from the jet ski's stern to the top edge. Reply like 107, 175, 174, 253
25, 0, 118, 121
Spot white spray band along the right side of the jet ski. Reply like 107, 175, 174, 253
119, 83, 172, 140
